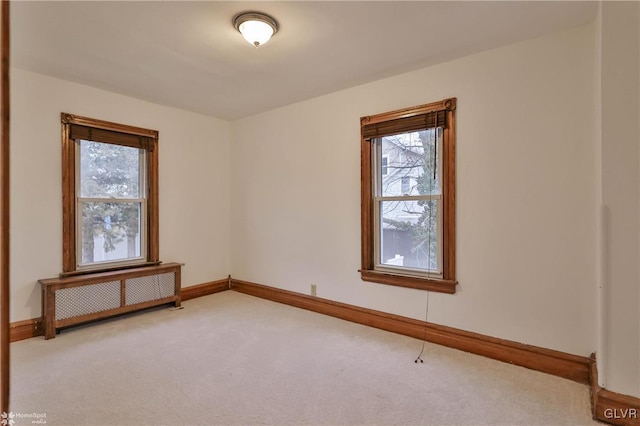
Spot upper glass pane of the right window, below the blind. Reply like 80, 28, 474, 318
378, 129, 440, 197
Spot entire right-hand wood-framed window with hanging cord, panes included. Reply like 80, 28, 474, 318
360, 98, 457, 293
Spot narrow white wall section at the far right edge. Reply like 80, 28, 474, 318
596, 2, 640, 397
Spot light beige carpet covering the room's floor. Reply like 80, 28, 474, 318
11, 291, 595, 426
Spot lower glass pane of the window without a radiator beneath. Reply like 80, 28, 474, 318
379, 200, 439, 271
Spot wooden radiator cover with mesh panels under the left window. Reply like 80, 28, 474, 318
39, 263, 181, 339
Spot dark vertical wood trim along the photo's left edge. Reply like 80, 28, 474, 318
0, 1, 10, 413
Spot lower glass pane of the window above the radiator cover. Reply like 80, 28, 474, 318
79, 202, 142, 265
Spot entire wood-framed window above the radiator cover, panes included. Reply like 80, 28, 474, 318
62, 113, 159, 273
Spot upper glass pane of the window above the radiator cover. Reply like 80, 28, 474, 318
80, 140, 144, 198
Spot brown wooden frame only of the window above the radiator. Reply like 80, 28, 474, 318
61, 113, 160, 275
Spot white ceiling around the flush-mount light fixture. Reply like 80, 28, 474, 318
11, 1, 597, 120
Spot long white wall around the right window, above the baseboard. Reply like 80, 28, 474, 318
231, 26, 596, 355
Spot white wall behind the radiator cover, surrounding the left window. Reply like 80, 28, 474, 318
10, 68, 230, 321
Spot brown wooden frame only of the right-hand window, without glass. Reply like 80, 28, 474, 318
360, 98, 458, 294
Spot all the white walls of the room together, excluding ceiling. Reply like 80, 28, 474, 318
11, 10, 640, 396
